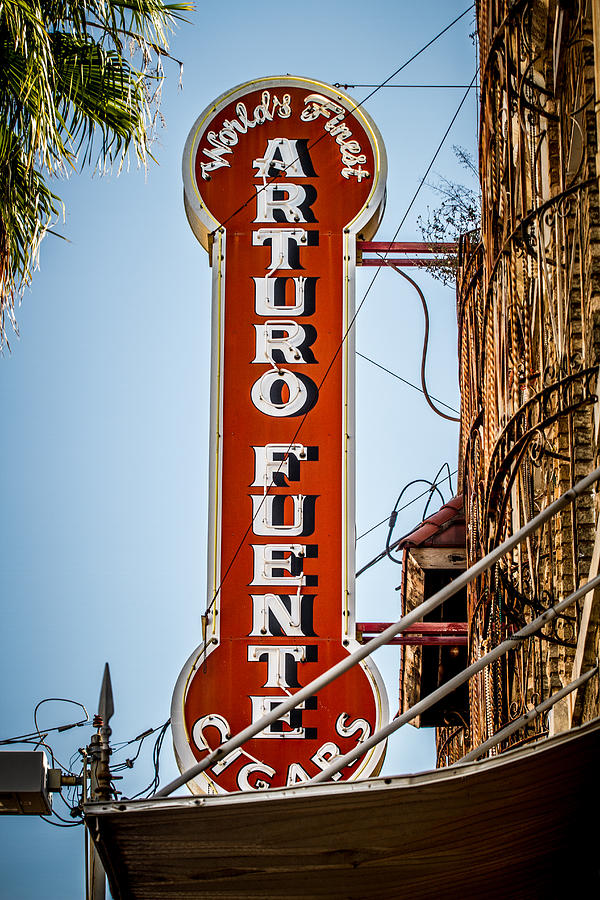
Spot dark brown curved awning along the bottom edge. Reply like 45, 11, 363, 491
85, 719, 600, 900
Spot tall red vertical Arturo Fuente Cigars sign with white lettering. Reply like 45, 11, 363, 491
172, 76, 387, 793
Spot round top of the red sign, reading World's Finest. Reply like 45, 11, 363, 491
183, 75, 387, 249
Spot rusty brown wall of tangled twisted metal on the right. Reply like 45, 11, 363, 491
454, 0, 600, 764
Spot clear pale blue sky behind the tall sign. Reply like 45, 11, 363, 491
0, 0, 477, 900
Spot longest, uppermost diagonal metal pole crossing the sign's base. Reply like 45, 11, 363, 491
154, 468, 600, 798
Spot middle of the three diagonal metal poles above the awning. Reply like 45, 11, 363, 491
305, 575, 600, 784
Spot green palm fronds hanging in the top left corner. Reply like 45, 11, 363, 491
0, 0, 192, 348
